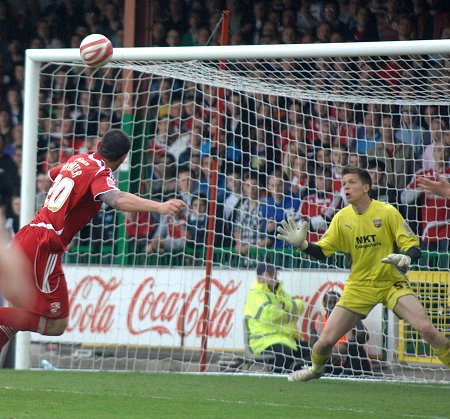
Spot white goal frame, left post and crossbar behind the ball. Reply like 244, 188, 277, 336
15, 39, 450, 369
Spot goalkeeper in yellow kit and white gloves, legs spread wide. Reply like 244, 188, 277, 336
277, 166, 450, 381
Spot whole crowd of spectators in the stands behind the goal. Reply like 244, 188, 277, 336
0, 0, 450, 262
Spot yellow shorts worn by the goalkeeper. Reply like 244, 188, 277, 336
337, 281, 415, 317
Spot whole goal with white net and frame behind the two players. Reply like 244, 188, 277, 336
17, 41, 450, 382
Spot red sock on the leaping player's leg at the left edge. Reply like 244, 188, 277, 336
0, 307, 47, 350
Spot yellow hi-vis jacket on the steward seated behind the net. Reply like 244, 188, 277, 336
244, 279, 305, 355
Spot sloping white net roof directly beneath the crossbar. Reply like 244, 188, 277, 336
110, 55, 450, 105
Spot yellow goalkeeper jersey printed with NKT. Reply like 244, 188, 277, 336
316, 200, 420, 287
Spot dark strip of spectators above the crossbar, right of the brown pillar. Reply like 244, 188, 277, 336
152, 0, 450, 46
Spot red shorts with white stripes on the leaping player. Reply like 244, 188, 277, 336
11, 225, 69, 319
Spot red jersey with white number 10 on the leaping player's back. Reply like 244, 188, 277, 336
30, 153, 117, 251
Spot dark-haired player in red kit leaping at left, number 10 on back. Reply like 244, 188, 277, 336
0, 129, 186, 358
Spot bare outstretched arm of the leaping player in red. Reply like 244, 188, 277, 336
100, 191, 186, 215
